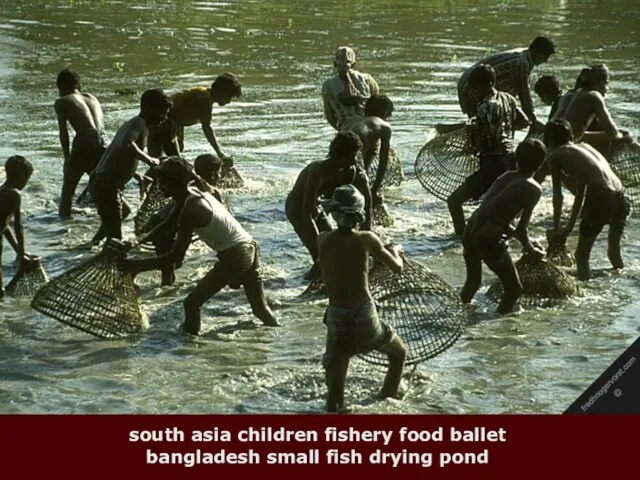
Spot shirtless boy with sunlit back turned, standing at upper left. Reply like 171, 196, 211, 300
54, 69, 105, 218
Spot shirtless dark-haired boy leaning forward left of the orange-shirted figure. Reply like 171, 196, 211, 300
89, 89, 171, 244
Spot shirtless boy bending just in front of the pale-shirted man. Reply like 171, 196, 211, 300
341, 95, 393, 206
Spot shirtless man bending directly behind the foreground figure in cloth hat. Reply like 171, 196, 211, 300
285, 132, 372, 280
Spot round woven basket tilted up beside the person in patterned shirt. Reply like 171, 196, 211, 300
415, 127, 479, 204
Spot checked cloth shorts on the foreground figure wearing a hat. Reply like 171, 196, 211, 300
322, 302, 395, 368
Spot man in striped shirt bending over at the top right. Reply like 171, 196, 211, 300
458, 36, 556, 128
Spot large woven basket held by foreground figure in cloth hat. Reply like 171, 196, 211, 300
358, 257, 467, 365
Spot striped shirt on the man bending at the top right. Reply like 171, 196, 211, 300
458, 48, 536, 122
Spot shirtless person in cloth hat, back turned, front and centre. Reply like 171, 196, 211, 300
318, 185, 406, 412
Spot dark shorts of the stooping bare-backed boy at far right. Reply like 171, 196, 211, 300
580, 185, 631, 237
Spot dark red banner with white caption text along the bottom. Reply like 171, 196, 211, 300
2, 415, 640, 480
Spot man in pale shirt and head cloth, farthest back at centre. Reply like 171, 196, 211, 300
322, 47, 380, 130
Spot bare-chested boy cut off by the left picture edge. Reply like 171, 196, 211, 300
0, 155, 33, 298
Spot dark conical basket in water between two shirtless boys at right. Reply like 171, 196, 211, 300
487, 255, 579, 308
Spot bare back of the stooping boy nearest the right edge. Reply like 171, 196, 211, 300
547, 143, 623, 192
